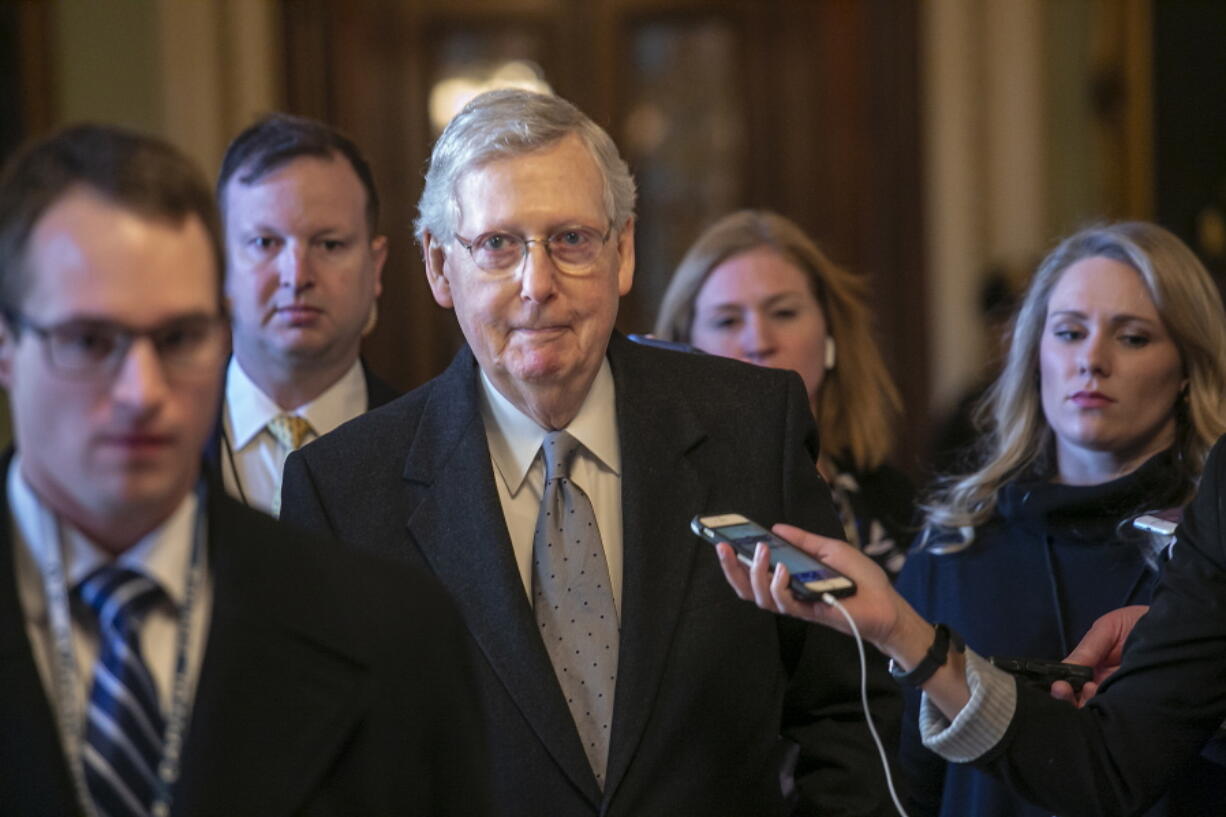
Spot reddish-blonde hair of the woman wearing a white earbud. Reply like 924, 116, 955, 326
655, 210, 902, 471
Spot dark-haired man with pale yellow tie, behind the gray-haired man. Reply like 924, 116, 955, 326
208, 114, 396, 515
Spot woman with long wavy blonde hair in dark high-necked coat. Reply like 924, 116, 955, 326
897, 222, 1226, 817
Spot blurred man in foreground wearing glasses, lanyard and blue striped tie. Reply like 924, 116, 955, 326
0, 125, 484, 817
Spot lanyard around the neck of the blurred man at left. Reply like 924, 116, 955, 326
39, 482, 205, 817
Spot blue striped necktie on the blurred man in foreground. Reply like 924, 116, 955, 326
77, 564, 166, 817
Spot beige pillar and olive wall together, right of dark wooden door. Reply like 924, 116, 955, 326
921, 0, 1151, 416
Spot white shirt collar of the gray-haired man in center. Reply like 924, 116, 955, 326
481, 359, 622, 496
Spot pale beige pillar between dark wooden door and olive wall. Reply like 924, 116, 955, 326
922, 0, 1047, 415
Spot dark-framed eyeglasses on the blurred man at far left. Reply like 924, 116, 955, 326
4, 310, 226, 380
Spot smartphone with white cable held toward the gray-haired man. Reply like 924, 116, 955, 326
690, 514, 856, 601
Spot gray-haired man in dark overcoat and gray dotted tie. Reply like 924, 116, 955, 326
283, 85, 900, 817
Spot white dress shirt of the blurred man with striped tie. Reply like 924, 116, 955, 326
6, 455, 212, 714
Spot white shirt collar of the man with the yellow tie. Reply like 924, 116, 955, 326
226, 357, 367, 450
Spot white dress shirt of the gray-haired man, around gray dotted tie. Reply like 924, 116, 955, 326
481, 359, 622, 613
